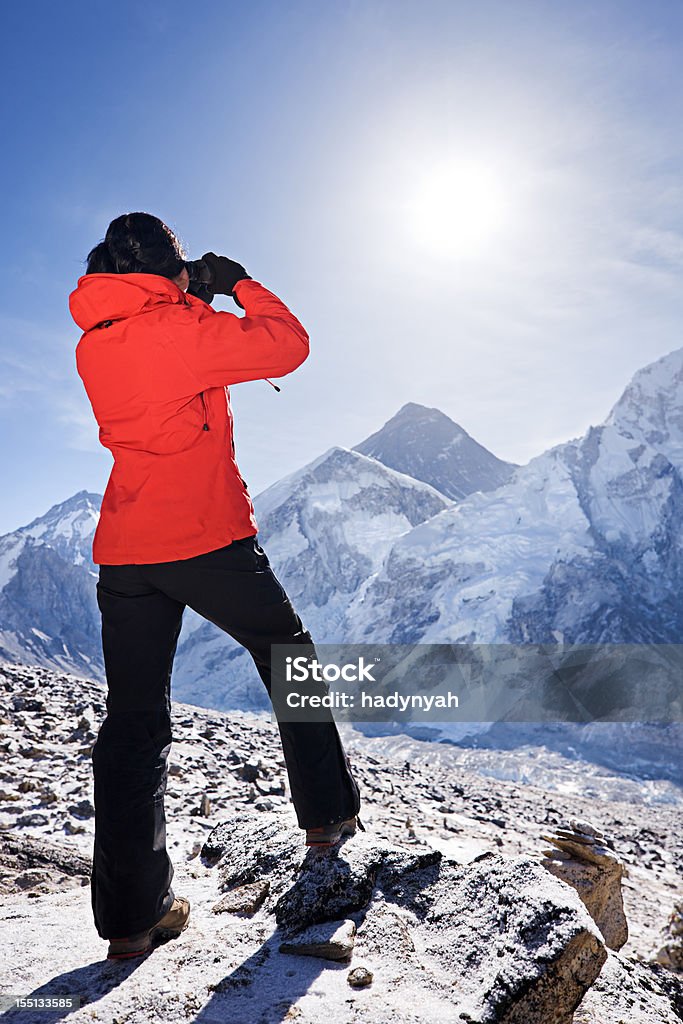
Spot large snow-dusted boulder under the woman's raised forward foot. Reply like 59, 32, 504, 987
202, 813, 607, 1024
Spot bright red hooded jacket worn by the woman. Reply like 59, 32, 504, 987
69, 273, 308, 565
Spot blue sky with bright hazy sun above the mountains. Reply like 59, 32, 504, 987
0, 0, 683, 532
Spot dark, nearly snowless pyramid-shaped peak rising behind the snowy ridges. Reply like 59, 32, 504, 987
354, 401, 516, 500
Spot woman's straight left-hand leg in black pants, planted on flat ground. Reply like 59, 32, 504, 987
91, 565, 184, 939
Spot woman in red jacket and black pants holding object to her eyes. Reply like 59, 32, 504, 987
69, 213, 360, 958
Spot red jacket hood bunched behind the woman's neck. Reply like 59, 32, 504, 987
69, 273, 191, 331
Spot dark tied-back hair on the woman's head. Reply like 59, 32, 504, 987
85, 213, 185, 278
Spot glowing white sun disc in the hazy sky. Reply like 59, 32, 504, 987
408, 160, 509, 259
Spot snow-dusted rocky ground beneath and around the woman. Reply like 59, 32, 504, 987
0, 665, 683, 1024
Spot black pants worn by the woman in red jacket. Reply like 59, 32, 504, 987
91, 537, 360, 939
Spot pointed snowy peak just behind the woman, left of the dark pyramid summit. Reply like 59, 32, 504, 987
173, 447, 451, 709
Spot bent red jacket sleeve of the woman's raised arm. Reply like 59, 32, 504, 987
169, 278, 308, 390
